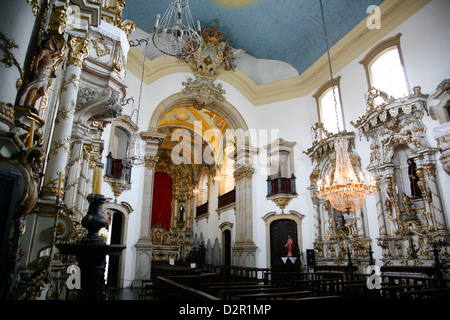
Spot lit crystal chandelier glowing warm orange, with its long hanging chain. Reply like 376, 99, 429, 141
317, 0, 376, 213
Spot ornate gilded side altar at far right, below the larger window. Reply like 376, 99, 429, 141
351, 87, 450, 266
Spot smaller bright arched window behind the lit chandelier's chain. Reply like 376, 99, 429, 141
313, 77, 345, 133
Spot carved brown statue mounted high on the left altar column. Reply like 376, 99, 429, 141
20, 36, 61, 107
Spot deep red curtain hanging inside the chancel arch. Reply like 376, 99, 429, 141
152, 171, 172, 230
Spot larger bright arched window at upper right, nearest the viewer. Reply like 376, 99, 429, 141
360, 33, 410, 98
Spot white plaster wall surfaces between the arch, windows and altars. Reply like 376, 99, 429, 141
110, 0, 450, 281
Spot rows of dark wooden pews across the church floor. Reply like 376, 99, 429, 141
139, 266, 450, 301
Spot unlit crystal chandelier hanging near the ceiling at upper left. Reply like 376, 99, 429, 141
152, 0, 201, 57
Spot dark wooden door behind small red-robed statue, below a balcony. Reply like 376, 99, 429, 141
270, 219, 299, 269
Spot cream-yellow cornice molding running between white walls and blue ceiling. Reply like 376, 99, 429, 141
127, 0, 431, 106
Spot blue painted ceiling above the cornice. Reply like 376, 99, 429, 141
123, 0, 383, 74
